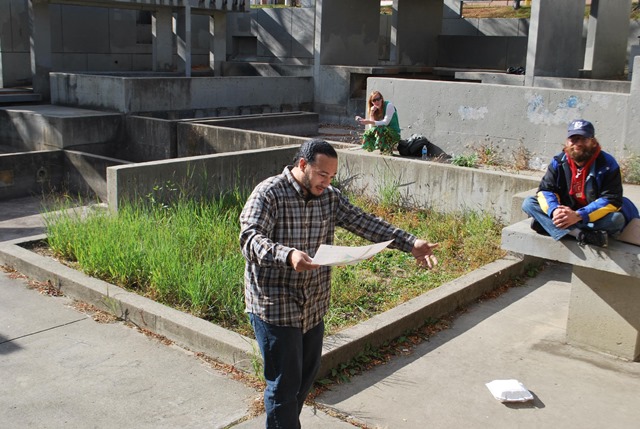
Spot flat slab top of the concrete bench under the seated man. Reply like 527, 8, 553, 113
502, 219, 640, 278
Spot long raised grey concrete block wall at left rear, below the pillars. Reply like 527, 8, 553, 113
51, 73, 313, 114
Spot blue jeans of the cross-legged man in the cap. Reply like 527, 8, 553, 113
522, 196, 625, 240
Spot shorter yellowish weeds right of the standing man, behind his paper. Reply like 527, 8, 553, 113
325, 197, 505, 334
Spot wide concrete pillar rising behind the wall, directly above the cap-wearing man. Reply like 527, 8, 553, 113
525, 0, 584, 86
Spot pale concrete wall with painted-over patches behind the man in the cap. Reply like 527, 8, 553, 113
367, 75, 640, 164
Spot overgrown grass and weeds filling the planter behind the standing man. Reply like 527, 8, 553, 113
45, 192, 504, 336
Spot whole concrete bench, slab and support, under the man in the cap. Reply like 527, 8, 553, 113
502, 219, 640, 361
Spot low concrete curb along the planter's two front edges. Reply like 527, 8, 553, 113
0, 235, 525, 377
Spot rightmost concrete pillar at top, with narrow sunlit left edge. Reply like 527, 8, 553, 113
584, 0, 631, 79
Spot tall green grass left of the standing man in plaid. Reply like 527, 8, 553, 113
45, 193, 246, 330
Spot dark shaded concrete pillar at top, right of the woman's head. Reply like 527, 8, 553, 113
389, 0, 444, 66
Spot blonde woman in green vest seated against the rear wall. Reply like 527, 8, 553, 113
356, 91, 400, 154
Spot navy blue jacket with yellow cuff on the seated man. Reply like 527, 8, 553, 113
537, 151, 638, 223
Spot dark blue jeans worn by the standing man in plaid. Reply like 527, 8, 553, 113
249, 313, 324, 429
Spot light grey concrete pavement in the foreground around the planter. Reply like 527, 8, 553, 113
0, 196, 640, 429
